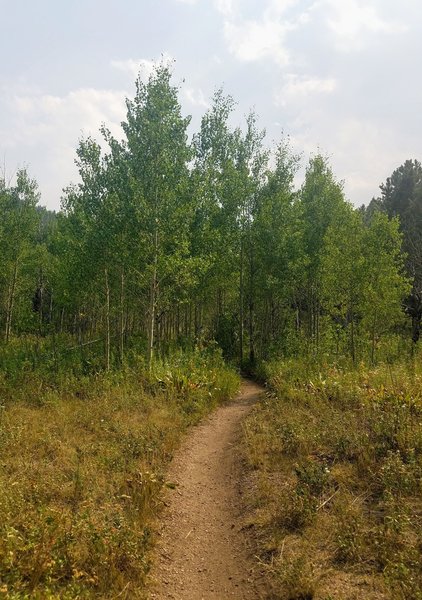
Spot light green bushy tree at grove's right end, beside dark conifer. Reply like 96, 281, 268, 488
322, 205, 410, 362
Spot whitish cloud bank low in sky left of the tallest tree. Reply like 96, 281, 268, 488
0, 86, 127, 208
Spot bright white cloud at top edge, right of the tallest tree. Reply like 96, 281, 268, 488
219, 0, 407, 67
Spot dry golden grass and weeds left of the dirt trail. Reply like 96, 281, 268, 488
0, 353, 239, 600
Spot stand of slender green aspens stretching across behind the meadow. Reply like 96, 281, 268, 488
0, 65, 422, 369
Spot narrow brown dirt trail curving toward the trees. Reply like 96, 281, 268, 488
150, 382, 265, 600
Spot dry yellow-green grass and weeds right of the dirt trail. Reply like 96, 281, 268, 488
245, 362, 422, 600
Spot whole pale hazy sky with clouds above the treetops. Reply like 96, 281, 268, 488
0, 0, 422, 210
